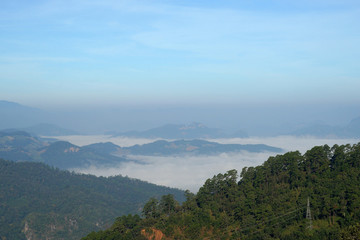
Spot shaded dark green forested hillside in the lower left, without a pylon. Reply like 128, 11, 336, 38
0, 159, 183, 240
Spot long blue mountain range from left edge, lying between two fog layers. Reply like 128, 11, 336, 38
0, 131, 282, 169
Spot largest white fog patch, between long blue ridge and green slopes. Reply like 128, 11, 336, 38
72, 152, 270, 192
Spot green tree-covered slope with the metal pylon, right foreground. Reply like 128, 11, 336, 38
83, 144, 360, 240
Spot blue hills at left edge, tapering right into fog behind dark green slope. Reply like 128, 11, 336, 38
0, 131, 130, 169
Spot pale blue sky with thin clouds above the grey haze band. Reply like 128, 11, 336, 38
0, 0, 360, 106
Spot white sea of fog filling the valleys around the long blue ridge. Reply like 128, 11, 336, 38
51, 135, 360, 193
